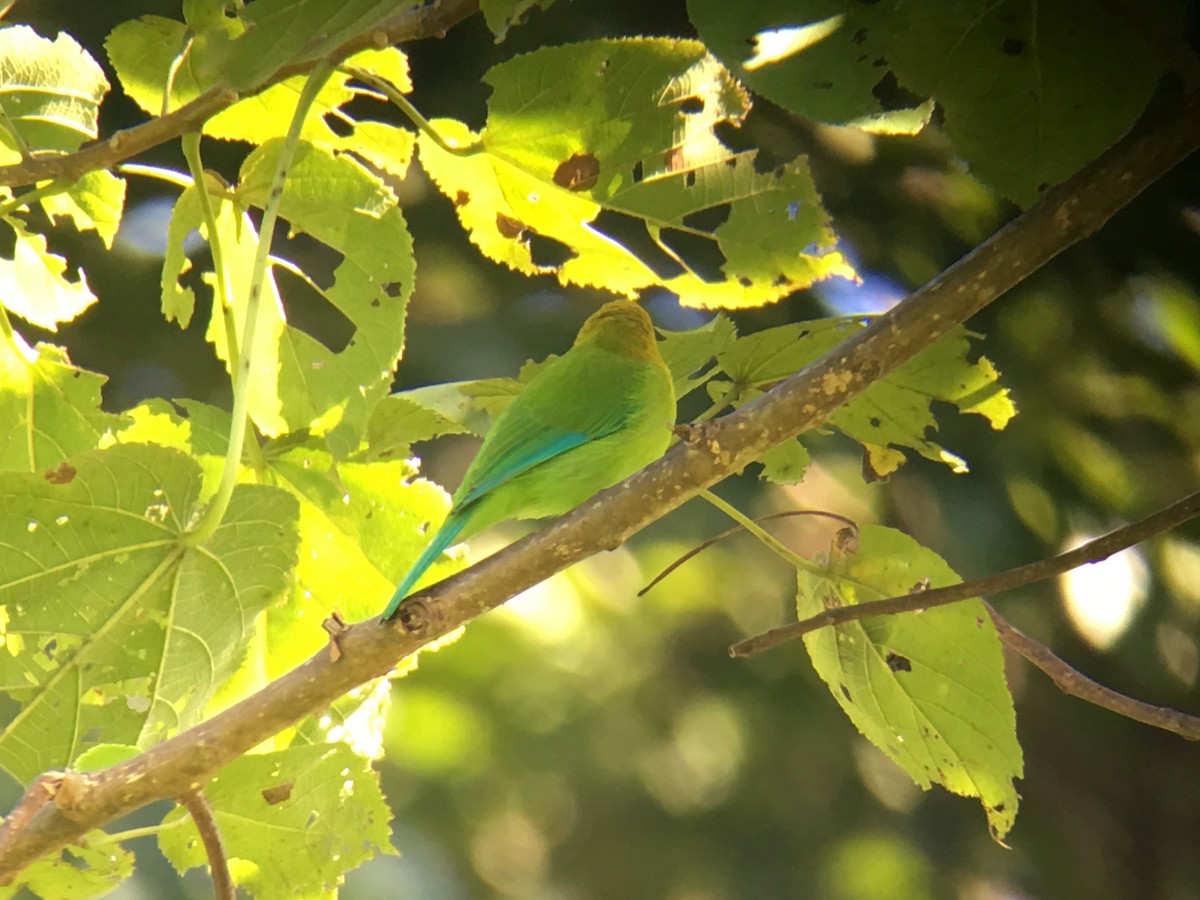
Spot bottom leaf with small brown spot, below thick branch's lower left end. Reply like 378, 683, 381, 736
158, 744, 396, 900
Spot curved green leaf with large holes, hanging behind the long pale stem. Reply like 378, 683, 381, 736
235, 142, 414, 457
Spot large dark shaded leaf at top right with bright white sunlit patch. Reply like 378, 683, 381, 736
688, 0, 1184, 205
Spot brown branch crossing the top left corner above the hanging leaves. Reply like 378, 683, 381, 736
0, 0, 479, 187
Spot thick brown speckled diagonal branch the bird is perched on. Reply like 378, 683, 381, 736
0, 75, 1200, 877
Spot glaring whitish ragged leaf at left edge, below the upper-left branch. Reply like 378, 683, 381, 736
0, 218, 96, 331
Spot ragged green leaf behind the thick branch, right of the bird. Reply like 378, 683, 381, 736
710, 317, 1016, 476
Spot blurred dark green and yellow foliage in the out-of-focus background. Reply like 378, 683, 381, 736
5, 0, 1200, 900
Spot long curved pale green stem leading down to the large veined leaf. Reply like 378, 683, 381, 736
182, 60, 334, 546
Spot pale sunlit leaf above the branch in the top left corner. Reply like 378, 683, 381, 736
0, 25, 108, 163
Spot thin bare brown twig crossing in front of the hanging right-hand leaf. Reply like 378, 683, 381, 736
730, 491, 1200, 656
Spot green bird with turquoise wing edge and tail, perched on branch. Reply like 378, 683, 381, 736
383, 300, 676, 620
